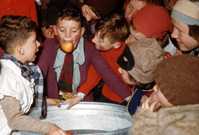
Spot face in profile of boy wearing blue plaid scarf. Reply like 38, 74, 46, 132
20, 32, 40, 63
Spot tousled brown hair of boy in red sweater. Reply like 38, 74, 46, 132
95, 13, 130, 43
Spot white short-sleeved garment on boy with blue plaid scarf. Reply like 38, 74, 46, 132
0, 59, 34, 135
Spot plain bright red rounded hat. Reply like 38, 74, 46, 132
133, 4, 172, 38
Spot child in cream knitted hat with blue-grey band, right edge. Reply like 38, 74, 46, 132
171, 0, 199, 56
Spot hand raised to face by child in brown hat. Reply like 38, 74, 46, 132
142, 97, 159, 112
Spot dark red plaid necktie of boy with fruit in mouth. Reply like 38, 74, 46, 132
58, 53, 73, 93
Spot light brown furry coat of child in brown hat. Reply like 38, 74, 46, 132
130, 104, 199, 135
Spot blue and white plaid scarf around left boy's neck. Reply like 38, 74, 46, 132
2, 52, 46, 118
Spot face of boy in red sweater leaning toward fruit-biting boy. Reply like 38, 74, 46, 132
92, 32, 121, 51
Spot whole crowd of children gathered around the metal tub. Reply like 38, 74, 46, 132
0, 0, 199, 135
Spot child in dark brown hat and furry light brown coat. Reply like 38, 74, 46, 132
130, 54, 199, 135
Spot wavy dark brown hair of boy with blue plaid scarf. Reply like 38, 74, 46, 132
0, 15, 37, 54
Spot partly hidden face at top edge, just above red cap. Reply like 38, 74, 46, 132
125, 0, 146, 22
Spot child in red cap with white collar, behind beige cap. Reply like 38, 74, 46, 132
127, 4, 175, 54
